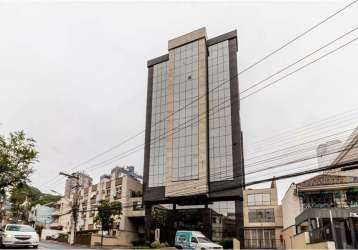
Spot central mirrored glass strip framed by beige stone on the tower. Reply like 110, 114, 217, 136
171, 42, 199, 181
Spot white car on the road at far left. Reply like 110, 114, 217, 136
0, 224, 39, 248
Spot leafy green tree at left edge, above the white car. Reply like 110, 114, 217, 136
0, 131, 38, 195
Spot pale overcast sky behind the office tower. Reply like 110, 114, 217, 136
0, 1, 358, 201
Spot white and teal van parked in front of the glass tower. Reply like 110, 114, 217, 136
175, 230, 223, 250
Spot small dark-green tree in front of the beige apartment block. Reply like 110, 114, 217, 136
96, 200, 122, 233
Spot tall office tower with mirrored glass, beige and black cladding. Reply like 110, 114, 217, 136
143, 28, 244, 246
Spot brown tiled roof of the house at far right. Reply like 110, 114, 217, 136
297, 174, 358, 187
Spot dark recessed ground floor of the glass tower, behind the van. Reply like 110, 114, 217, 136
146, 201, 243, 248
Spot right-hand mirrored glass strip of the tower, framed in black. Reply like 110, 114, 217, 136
208, 41, 233, 182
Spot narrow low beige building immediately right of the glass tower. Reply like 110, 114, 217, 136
244, 181, 283, 249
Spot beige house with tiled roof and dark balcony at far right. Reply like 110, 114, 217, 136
282, 174, 358, 249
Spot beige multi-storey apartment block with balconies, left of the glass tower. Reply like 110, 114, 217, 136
53, 167, 144, 246
